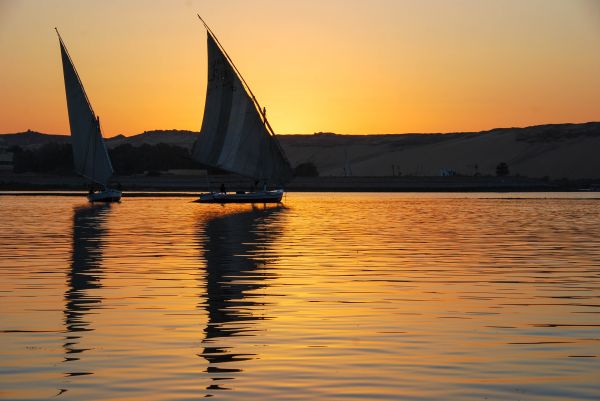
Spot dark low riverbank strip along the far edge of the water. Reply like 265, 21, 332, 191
0, 173, 598, 193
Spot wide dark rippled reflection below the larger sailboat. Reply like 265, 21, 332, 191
199, 206, 285, 396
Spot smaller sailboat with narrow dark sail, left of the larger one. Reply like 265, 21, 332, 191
54, 28, 122, 202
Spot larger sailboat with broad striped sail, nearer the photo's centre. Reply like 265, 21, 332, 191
192, 15, 293, 203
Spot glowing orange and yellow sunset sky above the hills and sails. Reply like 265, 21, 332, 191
0, 0, 600, 136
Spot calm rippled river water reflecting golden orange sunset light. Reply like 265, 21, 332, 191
0, 194, 600, 400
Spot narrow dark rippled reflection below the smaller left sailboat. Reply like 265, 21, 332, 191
63, 204, 111, 376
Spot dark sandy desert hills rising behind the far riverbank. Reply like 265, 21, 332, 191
0, 122, 600, 179
